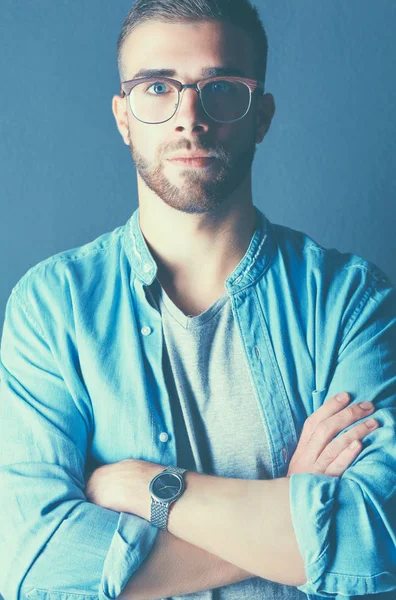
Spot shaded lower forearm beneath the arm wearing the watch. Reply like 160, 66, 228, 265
118, 531, 254, 600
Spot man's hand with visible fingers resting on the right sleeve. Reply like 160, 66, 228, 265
287, 393, 379, 477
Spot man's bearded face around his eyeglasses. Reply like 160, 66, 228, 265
113, 21, 268, 213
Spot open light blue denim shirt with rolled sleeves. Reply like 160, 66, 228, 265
0, 208, 396, 600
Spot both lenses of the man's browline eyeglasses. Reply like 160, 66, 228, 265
130, 78, 250, 123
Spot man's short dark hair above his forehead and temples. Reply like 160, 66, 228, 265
117, 0, 268, 81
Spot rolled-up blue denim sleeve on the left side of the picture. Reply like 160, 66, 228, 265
0, 289, 158, 600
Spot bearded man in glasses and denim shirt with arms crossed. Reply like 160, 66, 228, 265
0, 0, 396, 600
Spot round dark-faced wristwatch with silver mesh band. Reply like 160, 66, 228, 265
149, 466, 187, 531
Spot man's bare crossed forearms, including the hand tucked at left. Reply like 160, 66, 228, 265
87, 459, 306, 600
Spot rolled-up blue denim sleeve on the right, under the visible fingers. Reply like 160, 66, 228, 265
290, 277, 396, 598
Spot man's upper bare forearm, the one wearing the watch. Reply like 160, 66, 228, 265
122, 460, 306, 586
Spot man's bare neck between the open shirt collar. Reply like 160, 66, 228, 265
139, 180, 257, 289
